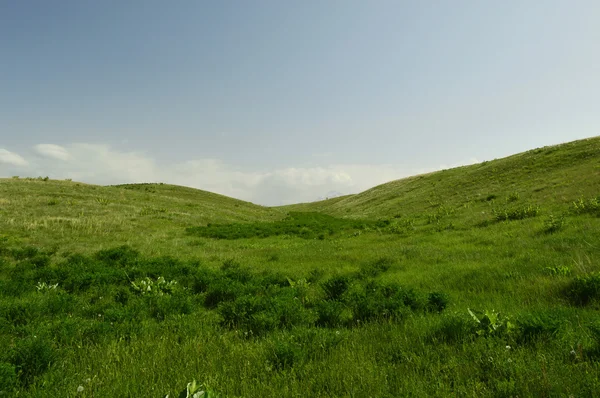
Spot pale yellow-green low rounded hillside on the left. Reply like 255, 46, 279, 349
0, 178, 282, 252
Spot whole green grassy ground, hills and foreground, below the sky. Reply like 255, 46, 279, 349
0, 138, 600, 397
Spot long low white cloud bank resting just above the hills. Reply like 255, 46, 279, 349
0, 144, 478, 205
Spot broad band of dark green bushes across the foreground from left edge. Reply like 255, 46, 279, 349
0, 244, 448, 391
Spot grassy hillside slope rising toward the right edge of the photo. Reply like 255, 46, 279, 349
281, 137, 600, 221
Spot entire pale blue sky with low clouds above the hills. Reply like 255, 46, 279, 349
0, 0, 600, 205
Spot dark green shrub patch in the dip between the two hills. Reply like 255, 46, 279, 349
187, 212, 382, 239
